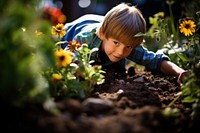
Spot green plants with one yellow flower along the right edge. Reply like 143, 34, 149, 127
164, 2, 200, 119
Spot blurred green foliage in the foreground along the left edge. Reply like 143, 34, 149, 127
0, 0, 53, 105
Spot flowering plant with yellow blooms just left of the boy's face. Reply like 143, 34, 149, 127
44, 24, 104, 98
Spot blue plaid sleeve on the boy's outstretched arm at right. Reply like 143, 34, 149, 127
128, 45, 170, 72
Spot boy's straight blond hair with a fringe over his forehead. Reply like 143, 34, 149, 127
101, 3, 146, 46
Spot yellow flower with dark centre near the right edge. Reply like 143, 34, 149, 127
179, 20, 196, 36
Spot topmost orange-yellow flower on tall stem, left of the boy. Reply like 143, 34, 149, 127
51, 24, 66, 37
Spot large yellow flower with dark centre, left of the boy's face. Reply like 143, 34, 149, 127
55, 49, 72, 67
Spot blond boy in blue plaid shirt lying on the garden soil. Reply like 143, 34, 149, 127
62, 3, 186, 83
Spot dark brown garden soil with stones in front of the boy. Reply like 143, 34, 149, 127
1, 68, 200, 133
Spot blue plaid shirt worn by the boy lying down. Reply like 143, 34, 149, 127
62, 14, 169, 72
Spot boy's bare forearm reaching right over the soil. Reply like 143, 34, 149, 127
160, 60, 188, 84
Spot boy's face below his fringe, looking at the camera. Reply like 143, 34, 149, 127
101, 38, 135, 62
